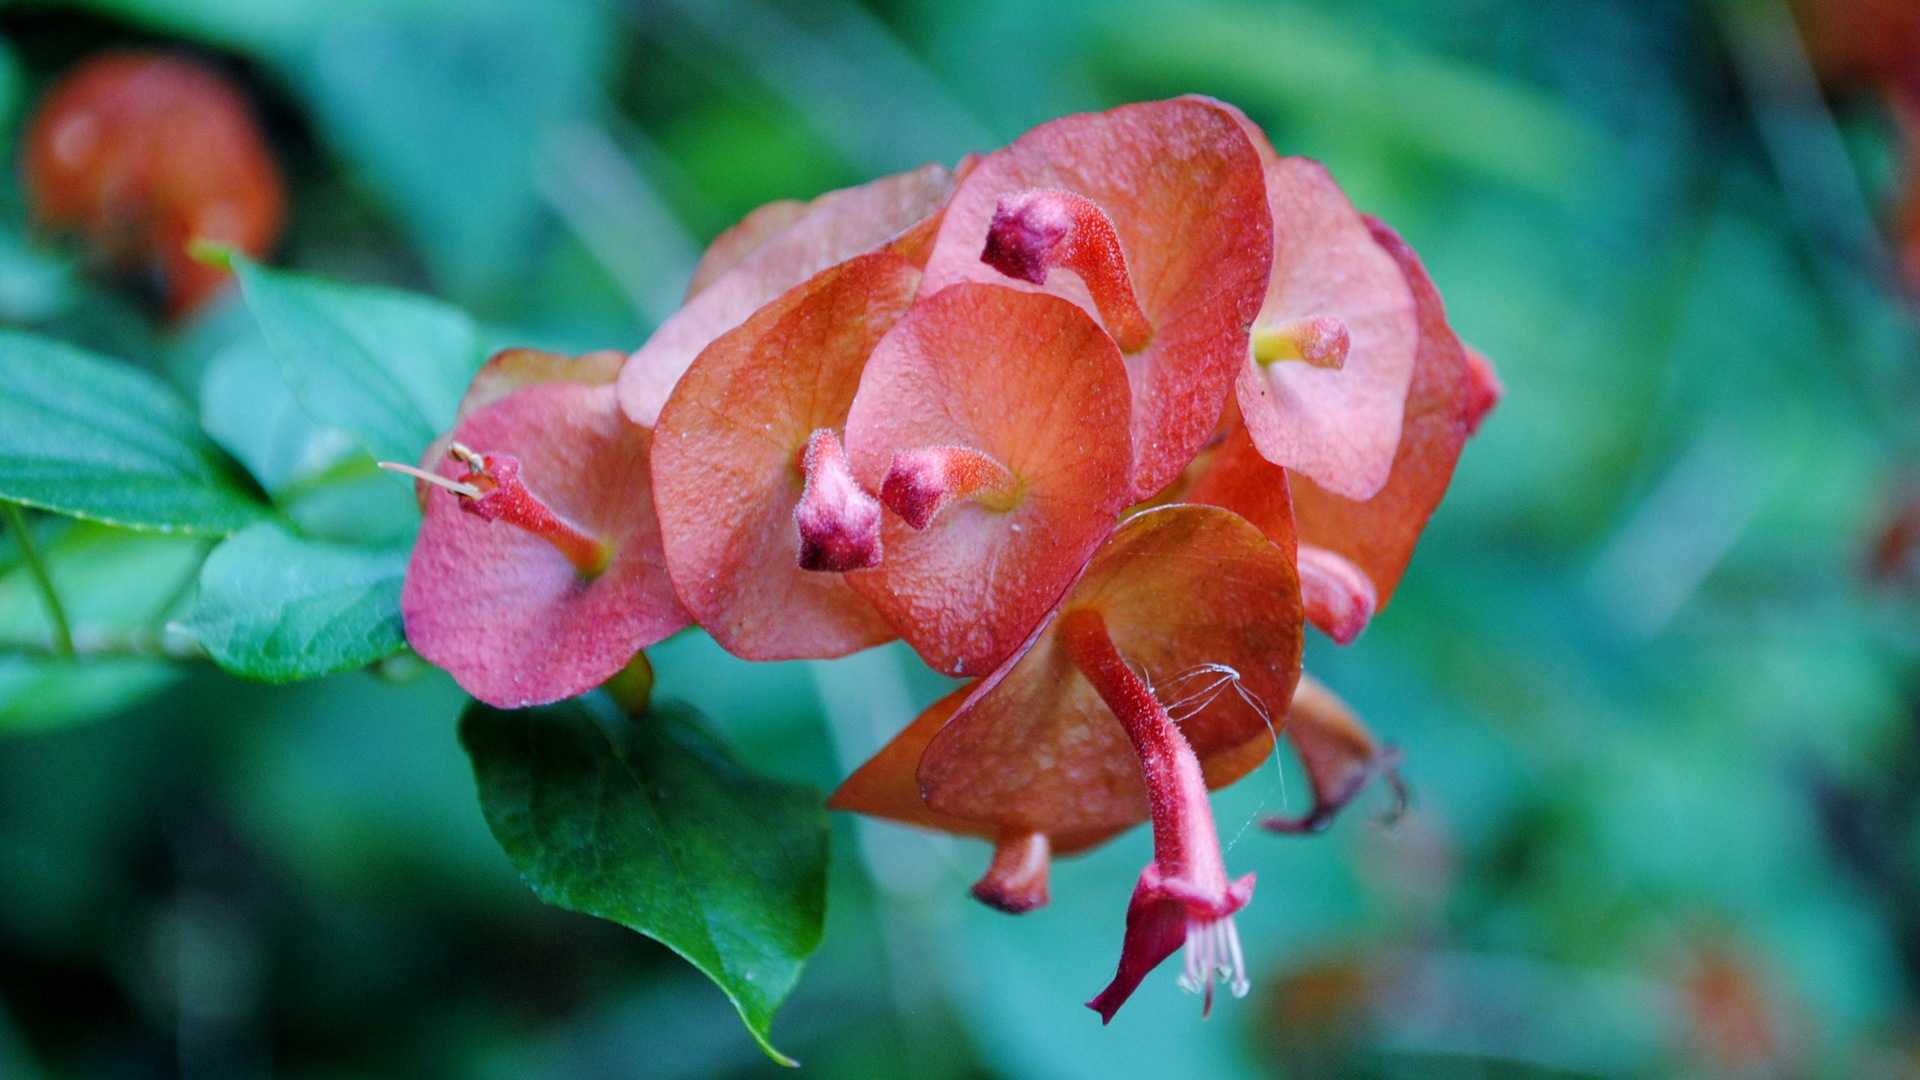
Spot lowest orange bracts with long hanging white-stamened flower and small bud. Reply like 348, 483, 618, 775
833, 505, 1302, 1019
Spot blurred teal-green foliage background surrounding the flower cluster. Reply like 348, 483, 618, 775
0, 0, 1920, 1080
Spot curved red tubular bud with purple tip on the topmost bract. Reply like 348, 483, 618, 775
979, 188, 1154, 354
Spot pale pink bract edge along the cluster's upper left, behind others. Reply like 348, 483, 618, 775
620, 165, 954, 429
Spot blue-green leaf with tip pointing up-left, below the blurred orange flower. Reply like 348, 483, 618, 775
232, 256, 480, 463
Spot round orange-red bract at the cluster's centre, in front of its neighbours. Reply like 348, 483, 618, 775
847, 284, 1129, 675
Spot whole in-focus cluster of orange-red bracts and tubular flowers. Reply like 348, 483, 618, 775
389, 98, 1500, 1019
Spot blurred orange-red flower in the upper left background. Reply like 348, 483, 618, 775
23, 50, 286, 319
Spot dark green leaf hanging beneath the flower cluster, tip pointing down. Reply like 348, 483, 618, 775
461, 694, 828, 1065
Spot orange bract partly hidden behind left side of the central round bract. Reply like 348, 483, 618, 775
653, 254, 920, 659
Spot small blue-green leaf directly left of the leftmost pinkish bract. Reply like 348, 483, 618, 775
180, 525, 407, 682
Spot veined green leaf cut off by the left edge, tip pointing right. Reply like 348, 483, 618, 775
0, 331, 267, 534
